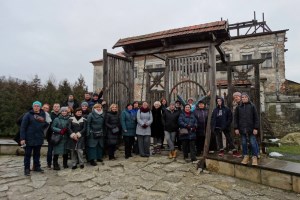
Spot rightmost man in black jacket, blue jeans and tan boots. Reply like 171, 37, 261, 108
234, 93, 259, 165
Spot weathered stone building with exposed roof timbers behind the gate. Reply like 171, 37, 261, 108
91, 17, 300, 135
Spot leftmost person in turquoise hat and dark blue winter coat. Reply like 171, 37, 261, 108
20, 101, 48, 176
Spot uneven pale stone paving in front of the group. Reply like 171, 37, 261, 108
0, 152, 300, 200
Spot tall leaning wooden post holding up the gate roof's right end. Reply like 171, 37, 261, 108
203, 43, 217, 159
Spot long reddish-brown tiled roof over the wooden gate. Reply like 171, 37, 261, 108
113, 21, 228, 48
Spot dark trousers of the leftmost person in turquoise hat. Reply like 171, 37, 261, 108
24, 145, 42, 170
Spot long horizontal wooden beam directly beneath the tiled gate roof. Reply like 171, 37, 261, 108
126, 42, 210, 56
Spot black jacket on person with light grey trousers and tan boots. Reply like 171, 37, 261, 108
163, 108, 181, 132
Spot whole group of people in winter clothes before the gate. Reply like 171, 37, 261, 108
20, 89, 259, 175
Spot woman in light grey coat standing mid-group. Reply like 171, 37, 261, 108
136, 102, 153, 157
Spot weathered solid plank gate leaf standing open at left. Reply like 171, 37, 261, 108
103, 49, 134, 110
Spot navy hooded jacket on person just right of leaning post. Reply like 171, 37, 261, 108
211, 98, 232, 131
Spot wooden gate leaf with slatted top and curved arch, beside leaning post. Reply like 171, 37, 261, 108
165, 54, 209, 101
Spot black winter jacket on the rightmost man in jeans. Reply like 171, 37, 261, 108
234, 102, 259, 134
